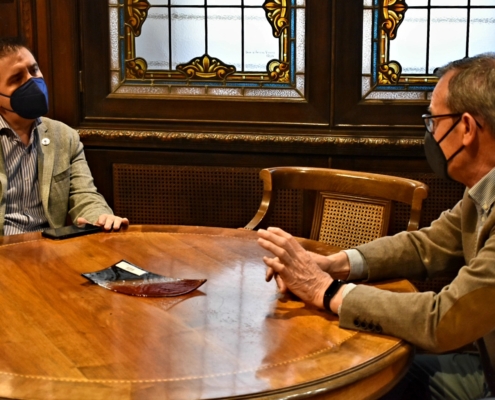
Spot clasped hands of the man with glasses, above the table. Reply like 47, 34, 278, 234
258, 228, 349, 312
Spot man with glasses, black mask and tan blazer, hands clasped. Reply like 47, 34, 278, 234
258, 54, 495, 399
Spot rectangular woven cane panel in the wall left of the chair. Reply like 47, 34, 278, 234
113, 164, 263, 228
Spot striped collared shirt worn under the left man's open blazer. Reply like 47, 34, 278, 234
0, 116, 48, 235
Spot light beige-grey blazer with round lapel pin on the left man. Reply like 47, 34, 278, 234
0, 118, 112, 235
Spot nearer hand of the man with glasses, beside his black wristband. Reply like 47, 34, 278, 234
258, 228, 333, 308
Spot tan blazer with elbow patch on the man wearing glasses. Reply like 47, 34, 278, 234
340, 191, 495, 390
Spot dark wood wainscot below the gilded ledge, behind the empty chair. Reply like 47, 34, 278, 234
86, 148, 464, 236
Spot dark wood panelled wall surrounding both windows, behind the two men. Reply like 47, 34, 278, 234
0, 0, 463, 238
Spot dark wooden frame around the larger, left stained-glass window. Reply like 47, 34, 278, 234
79, 1, 331, 127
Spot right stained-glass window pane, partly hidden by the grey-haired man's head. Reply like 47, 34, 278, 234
362, 0, 495, 101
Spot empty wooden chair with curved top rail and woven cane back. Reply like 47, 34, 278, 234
245, 167, 428, 248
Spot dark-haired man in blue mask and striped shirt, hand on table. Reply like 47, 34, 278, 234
0, 39, 128, 235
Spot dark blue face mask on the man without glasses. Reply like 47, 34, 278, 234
0, 78, 48, 119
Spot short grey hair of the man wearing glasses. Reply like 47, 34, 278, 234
435, 53, 495, 135
